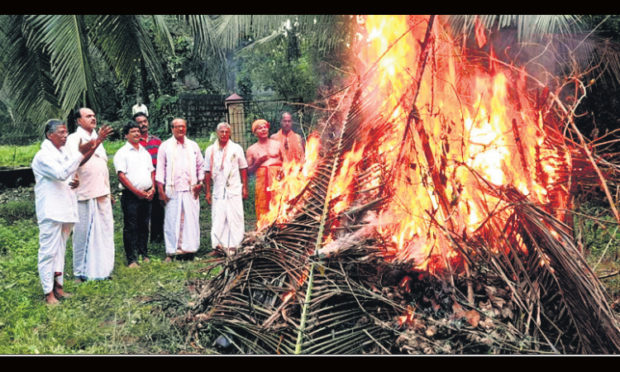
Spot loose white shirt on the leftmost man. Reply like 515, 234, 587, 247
32, 139, 84, 223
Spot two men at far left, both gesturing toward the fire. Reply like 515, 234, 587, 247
32, 108, 114, 304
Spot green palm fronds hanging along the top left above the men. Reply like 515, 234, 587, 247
0, 14, 352, 126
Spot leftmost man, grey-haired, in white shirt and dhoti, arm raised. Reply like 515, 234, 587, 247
32, 119, 95, 304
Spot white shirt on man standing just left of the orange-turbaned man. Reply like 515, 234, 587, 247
204, 140, 248, 200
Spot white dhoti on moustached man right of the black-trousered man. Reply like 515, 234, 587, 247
164, 191, 200, 256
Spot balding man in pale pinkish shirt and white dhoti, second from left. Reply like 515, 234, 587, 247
66, 107, 114, 282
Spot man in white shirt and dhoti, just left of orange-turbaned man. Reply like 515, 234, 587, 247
204, 123, 248, 254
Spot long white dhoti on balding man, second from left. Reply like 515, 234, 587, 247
73, 195, 114, 280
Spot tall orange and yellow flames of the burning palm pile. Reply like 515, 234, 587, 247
258, 15, 570, 273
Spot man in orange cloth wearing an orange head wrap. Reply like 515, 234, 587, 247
246, 119, 283, 221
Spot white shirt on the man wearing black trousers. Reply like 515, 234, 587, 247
114, 142, 155, 191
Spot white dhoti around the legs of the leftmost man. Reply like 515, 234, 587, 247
38, 220, 73, 294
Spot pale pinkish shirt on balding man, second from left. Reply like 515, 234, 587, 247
65, 126, 110, 200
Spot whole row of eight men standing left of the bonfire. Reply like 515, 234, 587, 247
32, 108, 304, 304
